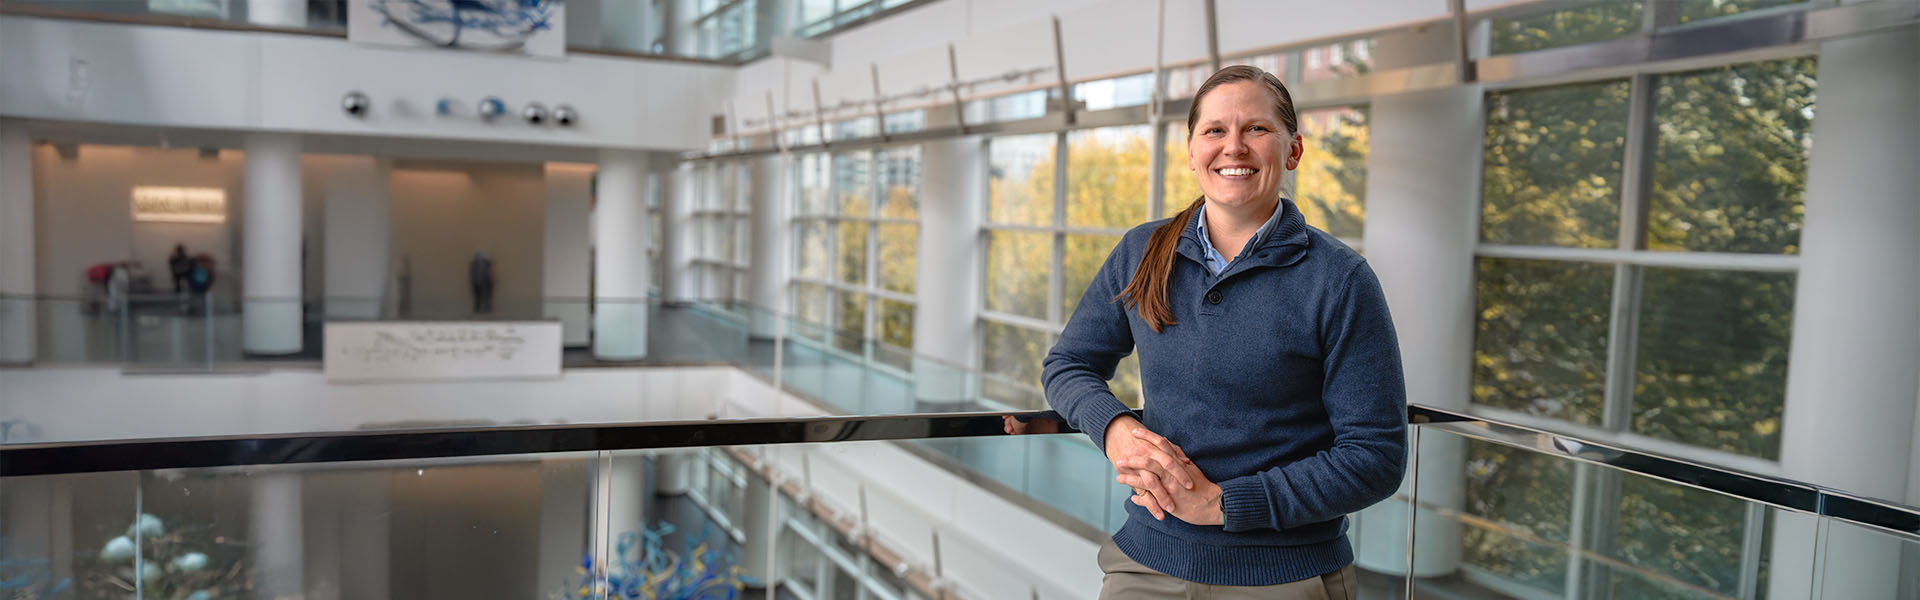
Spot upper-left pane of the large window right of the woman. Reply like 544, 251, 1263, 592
1480, 81, 1628, 248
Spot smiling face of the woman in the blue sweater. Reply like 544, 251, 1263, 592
1187, 81, 1300, 208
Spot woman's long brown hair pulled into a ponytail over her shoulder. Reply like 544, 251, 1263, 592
1114, 65, 1300, 333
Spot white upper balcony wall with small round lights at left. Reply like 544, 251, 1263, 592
0, 17, 733, 150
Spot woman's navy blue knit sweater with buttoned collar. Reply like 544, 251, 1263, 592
1041, 198, 1405, 585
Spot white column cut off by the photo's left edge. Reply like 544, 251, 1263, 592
0, 119, 38, 363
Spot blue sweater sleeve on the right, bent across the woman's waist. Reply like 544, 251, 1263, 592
1219, 262, 1407, 531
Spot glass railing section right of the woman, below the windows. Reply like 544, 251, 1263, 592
1397, 408, 1920, 598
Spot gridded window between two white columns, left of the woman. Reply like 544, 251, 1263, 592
793, 148, 920, 371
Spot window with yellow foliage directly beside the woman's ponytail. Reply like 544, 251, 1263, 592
981, 131, 1154, 408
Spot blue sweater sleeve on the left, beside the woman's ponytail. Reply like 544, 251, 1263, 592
1041, 242, 1133, 452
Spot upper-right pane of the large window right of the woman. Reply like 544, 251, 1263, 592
1647, 56, 1816, 254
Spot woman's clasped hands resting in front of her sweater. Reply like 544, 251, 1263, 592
1004, 415, 1225, 525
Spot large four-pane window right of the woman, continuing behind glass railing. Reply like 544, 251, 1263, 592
1467, 58, 1816, 598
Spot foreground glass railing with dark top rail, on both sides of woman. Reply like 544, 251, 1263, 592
0, 406, 1920, 598
